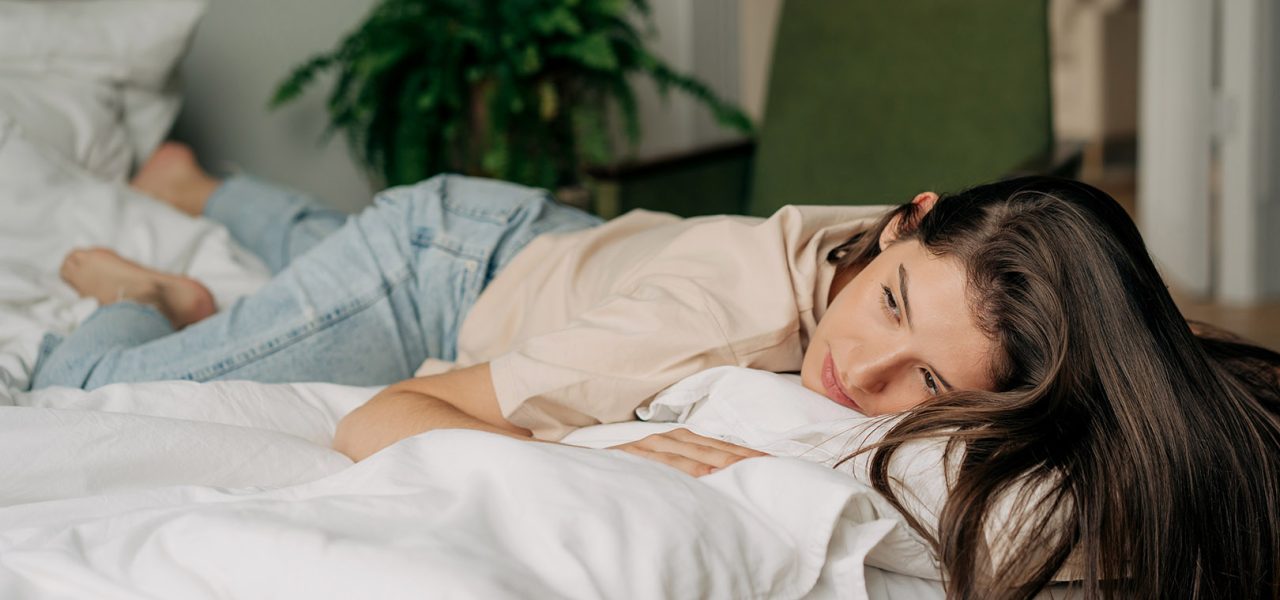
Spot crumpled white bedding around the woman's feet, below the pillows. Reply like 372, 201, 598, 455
0, 115, 269, 389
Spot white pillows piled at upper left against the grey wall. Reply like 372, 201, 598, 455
0, 0, 205, 180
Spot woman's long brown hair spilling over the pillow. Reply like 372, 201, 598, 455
828, 177, 1280, 599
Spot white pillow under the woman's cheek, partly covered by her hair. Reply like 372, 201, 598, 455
562, 367, 1080, 581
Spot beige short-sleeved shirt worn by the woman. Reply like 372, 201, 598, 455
419, 206, 887, 440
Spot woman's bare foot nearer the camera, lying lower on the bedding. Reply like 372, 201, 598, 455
60, 248, 216, 329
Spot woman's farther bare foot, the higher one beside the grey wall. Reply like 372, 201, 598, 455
129, 142, 220, 216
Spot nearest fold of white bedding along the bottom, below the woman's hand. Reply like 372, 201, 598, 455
0, 430, 891, 599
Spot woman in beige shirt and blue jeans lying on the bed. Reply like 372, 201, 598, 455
35, 142, 1280, 597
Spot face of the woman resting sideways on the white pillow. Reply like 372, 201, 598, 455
800, 239, 995, 416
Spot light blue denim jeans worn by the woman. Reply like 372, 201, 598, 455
32, 175, 602, 389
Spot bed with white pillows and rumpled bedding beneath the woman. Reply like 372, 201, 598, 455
0, 0, 1066, 599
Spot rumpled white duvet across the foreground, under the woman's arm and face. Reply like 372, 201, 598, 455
0, 367, 952, 599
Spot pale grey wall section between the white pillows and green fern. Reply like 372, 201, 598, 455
173, 0, 374, 211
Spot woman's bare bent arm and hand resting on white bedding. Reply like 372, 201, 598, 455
333, 362, 765, 477
